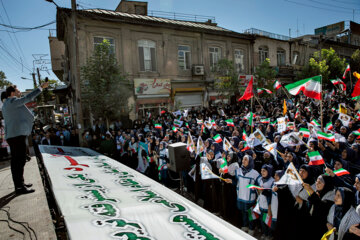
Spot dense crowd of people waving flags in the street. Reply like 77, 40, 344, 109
29, 89, 360, 240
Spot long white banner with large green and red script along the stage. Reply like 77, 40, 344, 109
40, 145, 255, 240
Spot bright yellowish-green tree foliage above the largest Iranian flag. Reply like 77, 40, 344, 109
298, 48, 346, 84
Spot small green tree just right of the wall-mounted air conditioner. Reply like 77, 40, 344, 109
214, 59, 240, 99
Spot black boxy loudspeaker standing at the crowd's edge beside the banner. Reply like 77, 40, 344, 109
168, 142, 190, 172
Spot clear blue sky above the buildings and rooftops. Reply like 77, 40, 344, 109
0, 0, 360, 90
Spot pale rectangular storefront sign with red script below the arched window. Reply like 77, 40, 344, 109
134, 78, 171, 95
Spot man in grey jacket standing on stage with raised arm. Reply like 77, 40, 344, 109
2, 82, 49, 194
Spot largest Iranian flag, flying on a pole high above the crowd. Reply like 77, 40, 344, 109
285, 75, 321, 100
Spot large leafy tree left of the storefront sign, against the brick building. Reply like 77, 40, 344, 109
81, 40, 131, 127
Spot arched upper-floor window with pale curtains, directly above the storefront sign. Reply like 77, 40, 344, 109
138, 40, 156, 72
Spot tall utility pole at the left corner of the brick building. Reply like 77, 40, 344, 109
71, 0, 84, 145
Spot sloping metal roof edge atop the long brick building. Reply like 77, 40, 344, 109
82, 9, 233, 32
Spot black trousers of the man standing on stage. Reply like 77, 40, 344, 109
7, 136, 26, 189
